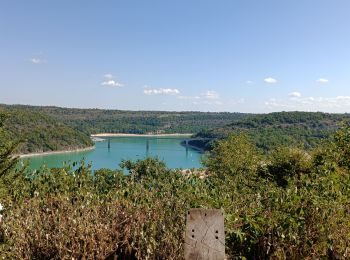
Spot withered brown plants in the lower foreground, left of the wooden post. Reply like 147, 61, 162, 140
2, 197, 183, 259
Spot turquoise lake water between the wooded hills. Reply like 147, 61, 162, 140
24, 137, 202, 170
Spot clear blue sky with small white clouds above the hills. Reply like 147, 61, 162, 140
0, 0, 350, 113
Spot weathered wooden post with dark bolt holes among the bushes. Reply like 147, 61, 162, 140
185, 209, 225, 260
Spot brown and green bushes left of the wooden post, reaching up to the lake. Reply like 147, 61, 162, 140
0, 159, 211, 259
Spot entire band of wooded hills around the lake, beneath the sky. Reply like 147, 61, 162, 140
0, 105, 350, 153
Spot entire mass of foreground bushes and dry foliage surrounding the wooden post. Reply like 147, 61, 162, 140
0, 110, 350, 259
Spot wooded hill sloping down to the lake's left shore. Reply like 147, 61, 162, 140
0, 108, 93, 153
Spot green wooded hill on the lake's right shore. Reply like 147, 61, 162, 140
191, 112, 350, 151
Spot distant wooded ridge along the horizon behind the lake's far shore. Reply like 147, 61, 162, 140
1, 105, 247, 134
